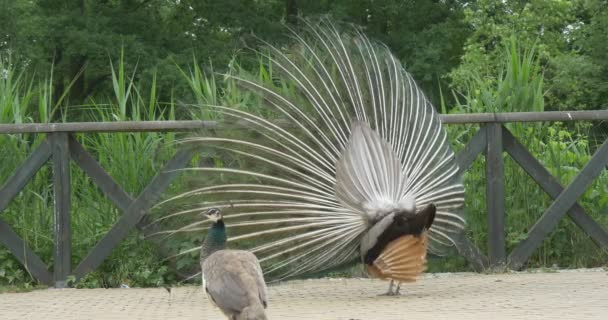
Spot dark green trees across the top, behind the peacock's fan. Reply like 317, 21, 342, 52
0, 0, 468, 109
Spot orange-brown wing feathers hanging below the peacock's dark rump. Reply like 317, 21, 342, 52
368, 232, 427, 282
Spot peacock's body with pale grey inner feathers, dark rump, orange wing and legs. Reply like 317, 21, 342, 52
336, 122, 437, 295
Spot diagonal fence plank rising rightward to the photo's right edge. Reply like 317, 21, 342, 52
509, 136, 608, 269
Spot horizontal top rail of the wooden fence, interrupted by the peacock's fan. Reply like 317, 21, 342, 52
0, 110, 608, 134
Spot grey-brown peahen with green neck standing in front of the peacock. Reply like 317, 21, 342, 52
201, 208, 268, 320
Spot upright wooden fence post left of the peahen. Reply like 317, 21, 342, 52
49, 132, 72, 288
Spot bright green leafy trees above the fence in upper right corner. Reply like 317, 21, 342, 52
449, 0, 608, 110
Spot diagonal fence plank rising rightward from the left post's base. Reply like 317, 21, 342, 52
74, 149, 194, 278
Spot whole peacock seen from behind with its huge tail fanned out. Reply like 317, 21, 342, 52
150, 18, 465, 295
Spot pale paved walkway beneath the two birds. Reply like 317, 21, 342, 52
0, 270, 608, 320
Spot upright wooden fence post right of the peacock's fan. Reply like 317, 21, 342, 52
486, 123, 506, 266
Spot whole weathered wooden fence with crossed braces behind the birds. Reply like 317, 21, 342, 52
0, 110, 608, 287
